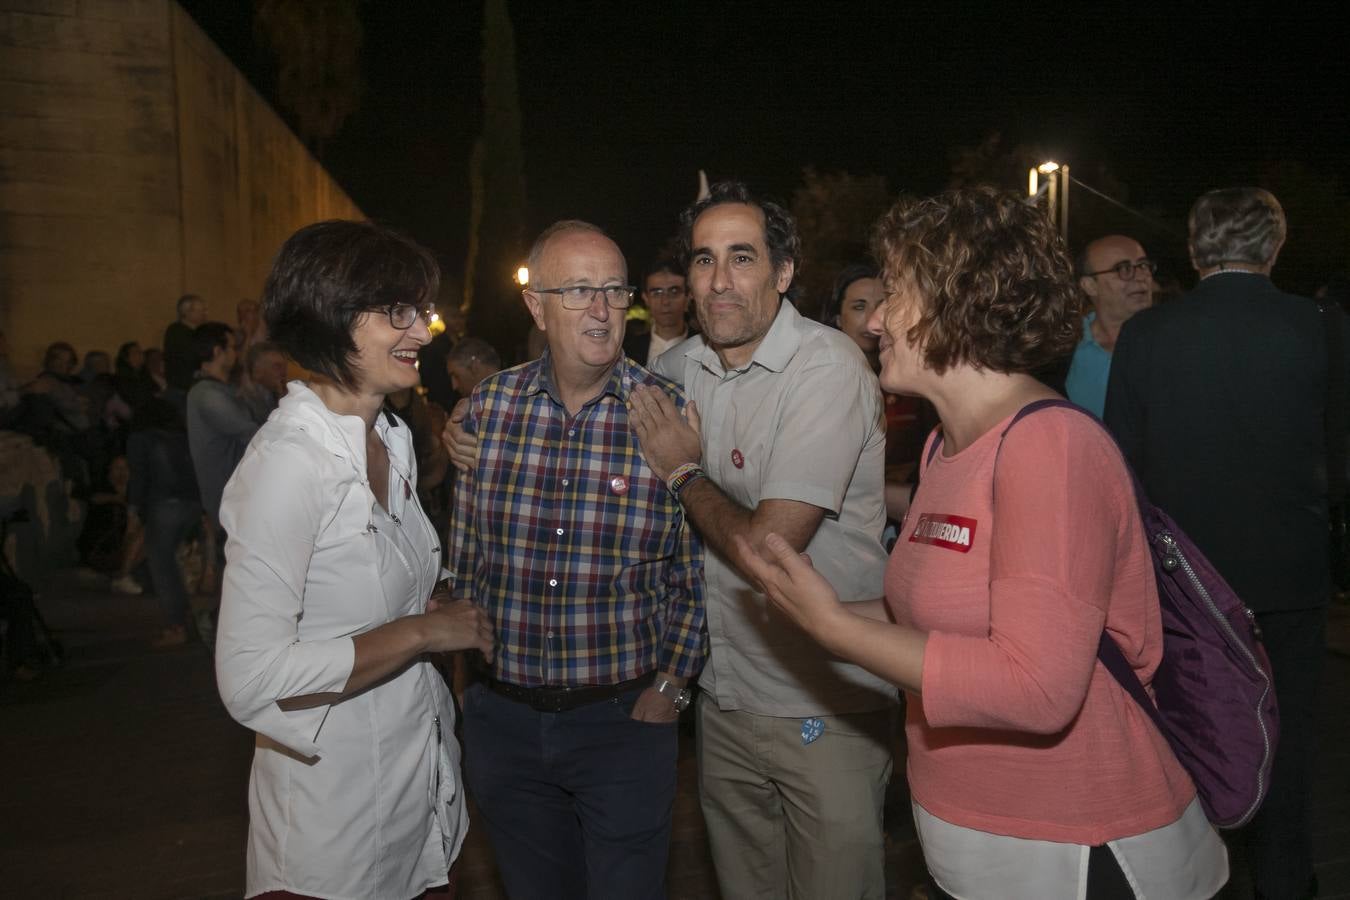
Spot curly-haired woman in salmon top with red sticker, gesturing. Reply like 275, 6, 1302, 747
740, 189, 1229, 900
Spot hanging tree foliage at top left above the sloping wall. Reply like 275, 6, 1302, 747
254, 0, 365, 155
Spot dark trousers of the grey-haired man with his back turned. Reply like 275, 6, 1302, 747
1242, 609, 1327, 900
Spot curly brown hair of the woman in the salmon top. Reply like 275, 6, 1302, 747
872, 188, 1081, 374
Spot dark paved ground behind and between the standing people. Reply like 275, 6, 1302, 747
0, 584, 1350, 900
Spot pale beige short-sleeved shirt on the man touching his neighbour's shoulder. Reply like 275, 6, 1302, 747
656, 302, 896, 716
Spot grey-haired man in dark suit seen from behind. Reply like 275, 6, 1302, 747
1106, 188, 1331, 897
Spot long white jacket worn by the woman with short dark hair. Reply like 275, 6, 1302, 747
216, 382, 467, 900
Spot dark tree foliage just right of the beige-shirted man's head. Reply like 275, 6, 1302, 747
792, 169, 891, 318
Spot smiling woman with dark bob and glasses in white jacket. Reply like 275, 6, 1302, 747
216, 221, 493, 900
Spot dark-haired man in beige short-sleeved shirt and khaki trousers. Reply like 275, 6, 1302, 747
630, 182, 896, 899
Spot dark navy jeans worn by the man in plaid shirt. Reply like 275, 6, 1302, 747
464, 684, 678, 900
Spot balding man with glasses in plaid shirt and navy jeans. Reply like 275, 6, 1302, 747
451, 221, 707, 900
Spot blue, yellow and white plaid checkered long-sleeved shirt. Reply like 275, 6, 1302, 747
450, 349, 707, 687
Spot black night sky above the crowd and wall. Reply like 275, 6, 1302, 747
185, 0, 1350, 292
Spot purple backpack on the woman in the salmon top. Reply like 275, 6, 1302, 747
988, 399, 1280, 828
